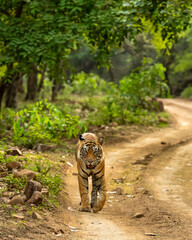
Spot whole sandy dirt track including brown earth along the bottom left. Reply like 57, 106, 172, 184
0, 99, 192, 240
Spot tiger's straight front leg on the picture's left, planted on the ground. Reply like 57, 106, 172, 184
78, 174, 91, 212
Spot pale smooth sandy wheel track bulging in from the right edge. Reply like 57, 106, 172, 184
150, 141, 192, 217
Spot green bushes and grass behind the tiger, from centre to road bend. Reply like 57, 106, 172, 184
56, 59, 170, 128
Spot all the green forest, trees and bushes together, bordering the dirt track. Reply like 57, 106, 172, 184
0, 0, 192, 218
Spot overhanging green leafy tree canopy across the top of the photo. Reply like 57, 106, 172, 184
0, 0, 191, 107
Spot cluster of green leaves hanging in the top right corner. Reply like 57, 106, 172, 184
123, 0, 191, 40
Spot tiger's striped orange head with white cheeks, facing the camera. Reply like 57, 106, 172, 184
79, 133, 103, 169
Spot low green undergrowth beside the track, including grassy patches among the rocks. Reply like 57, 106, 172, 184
0, 59, 169, 209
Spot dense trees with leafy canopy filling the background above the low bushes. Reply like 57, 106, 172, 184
0, 0, 191, 125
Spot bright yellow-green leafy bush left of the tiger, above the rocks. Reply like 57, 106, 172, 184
13, 101, 86, 147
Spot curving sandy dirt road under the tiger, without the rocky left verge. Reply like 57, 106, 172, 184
62, 99, 192, 240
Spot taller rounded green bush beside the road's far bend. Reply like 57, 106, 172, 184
99, 59, 169, 124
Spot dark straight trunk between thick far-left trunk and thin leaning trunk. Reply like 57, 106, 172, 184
25, 64, 38, 100
